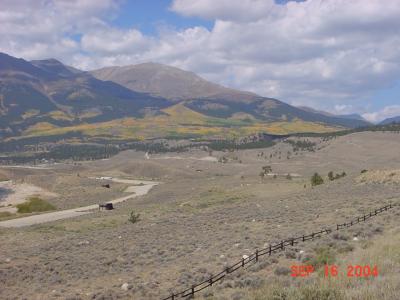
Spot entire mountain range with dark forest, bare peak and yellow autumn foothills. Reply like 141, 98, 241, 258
0, 53, 369, 139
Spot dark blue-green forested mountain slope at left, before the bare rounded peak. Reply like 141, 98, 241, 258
0, 54, 170, 136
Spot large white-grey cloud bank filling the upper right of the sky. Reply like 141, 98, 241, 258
172, 0, 400, 111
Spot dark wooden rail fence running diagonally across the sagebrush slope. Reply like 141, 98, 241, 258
162, 203, 398, 300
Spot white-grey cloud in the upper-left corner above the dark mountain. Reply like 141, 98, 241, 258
0, 0, 118, 59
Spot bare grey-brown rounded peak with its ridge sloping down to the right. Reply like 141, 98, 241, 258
90, 63, 369, 128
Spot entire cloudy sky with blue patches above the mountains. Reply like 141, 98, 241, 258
0, 0, 400, 122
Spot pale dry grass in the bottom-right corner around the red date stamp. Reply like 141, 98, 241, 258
238, 221, 400, 300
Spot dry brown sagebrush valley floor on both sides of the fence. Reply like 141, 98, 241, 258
0, 132, 400, 300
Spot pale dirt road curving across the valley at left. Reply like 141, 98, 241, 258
0, 178, 159, 227
